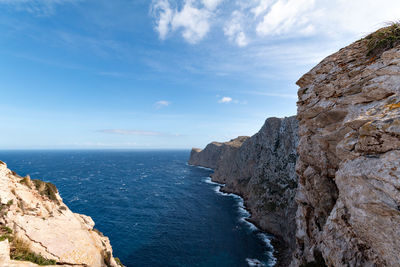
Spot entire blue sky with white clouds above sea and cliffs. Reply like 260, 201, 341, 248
0, 0, 400, 149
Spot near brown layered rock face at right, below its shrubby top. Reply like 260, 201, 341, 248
292, 33, 400, 266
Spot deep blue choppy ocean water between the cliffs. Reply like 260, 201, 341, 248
0, 151, 274, 267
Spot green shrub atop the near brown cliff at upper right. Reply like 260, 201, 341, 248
365, 22, 400, 56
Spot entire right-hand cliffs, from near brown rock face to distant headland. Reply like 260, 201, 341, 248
191, 24, 400, 267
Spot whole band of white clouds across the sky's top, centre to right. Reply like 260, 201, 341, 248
149, 0, 400, 47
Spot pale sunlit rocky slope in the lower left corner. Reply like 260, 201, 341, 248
0, 161, 119, 267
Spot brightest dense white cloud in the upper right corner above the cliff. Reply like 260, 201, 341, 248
251, 0, 400, 38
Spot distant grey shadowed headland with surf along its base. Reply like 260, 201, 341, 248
189, 117, 298, 266
